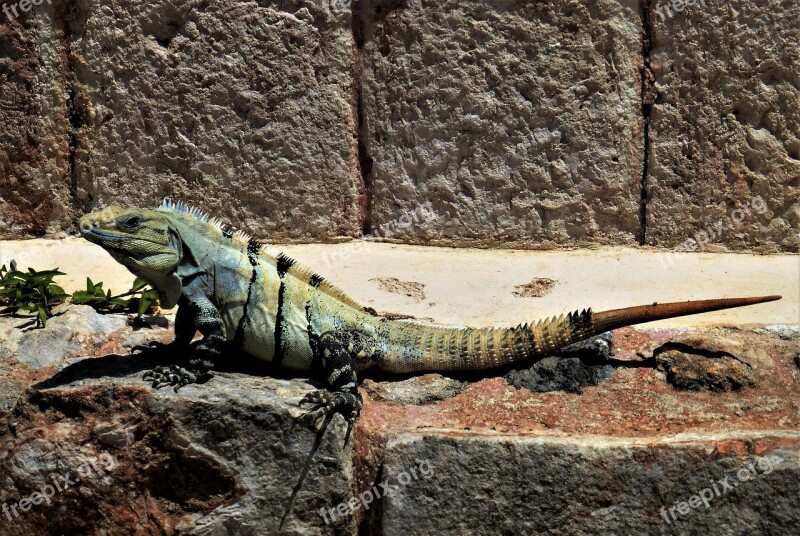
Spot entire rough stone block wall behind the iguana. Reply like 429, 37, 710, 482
0, 0, 800, 251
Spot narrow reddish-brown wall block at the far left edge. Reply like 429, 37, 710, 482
0, 6, 72, 238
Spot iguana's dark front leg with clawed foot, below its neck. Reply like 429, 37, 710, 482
143, 289, 225, 391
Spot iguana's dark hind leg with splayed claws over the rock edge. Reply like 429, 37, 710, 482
300, 332, 362, 432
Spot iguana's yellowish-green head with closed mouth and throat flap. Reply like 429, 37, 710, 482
78, 206, 182, 307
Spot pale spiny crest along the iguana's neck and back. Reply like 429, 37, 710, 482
158, 197, 364, 311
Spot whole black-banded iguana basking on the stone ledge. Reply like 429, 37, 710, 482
79, 200, 781, 423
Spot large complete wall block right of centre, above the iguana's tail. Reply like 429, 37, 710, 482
361, 0, 644, 247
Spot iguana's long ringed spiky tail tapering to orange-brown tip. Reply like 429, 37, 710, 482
378, 296, 781, 373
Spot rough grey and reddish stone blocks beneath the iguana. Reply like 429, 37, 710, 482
0, 314, 800, 535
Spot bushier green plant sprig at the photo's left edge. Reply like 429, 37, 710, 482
0, 260, 69, 327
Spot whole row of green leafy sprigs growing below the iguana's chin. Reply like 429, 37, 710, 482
0, 260, 158, 328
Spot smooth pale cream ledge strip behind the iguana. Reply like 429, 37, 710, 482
0, 238, 800, 327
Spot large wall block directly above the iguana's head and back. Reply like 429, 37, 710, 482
69, 0, 362, 241
